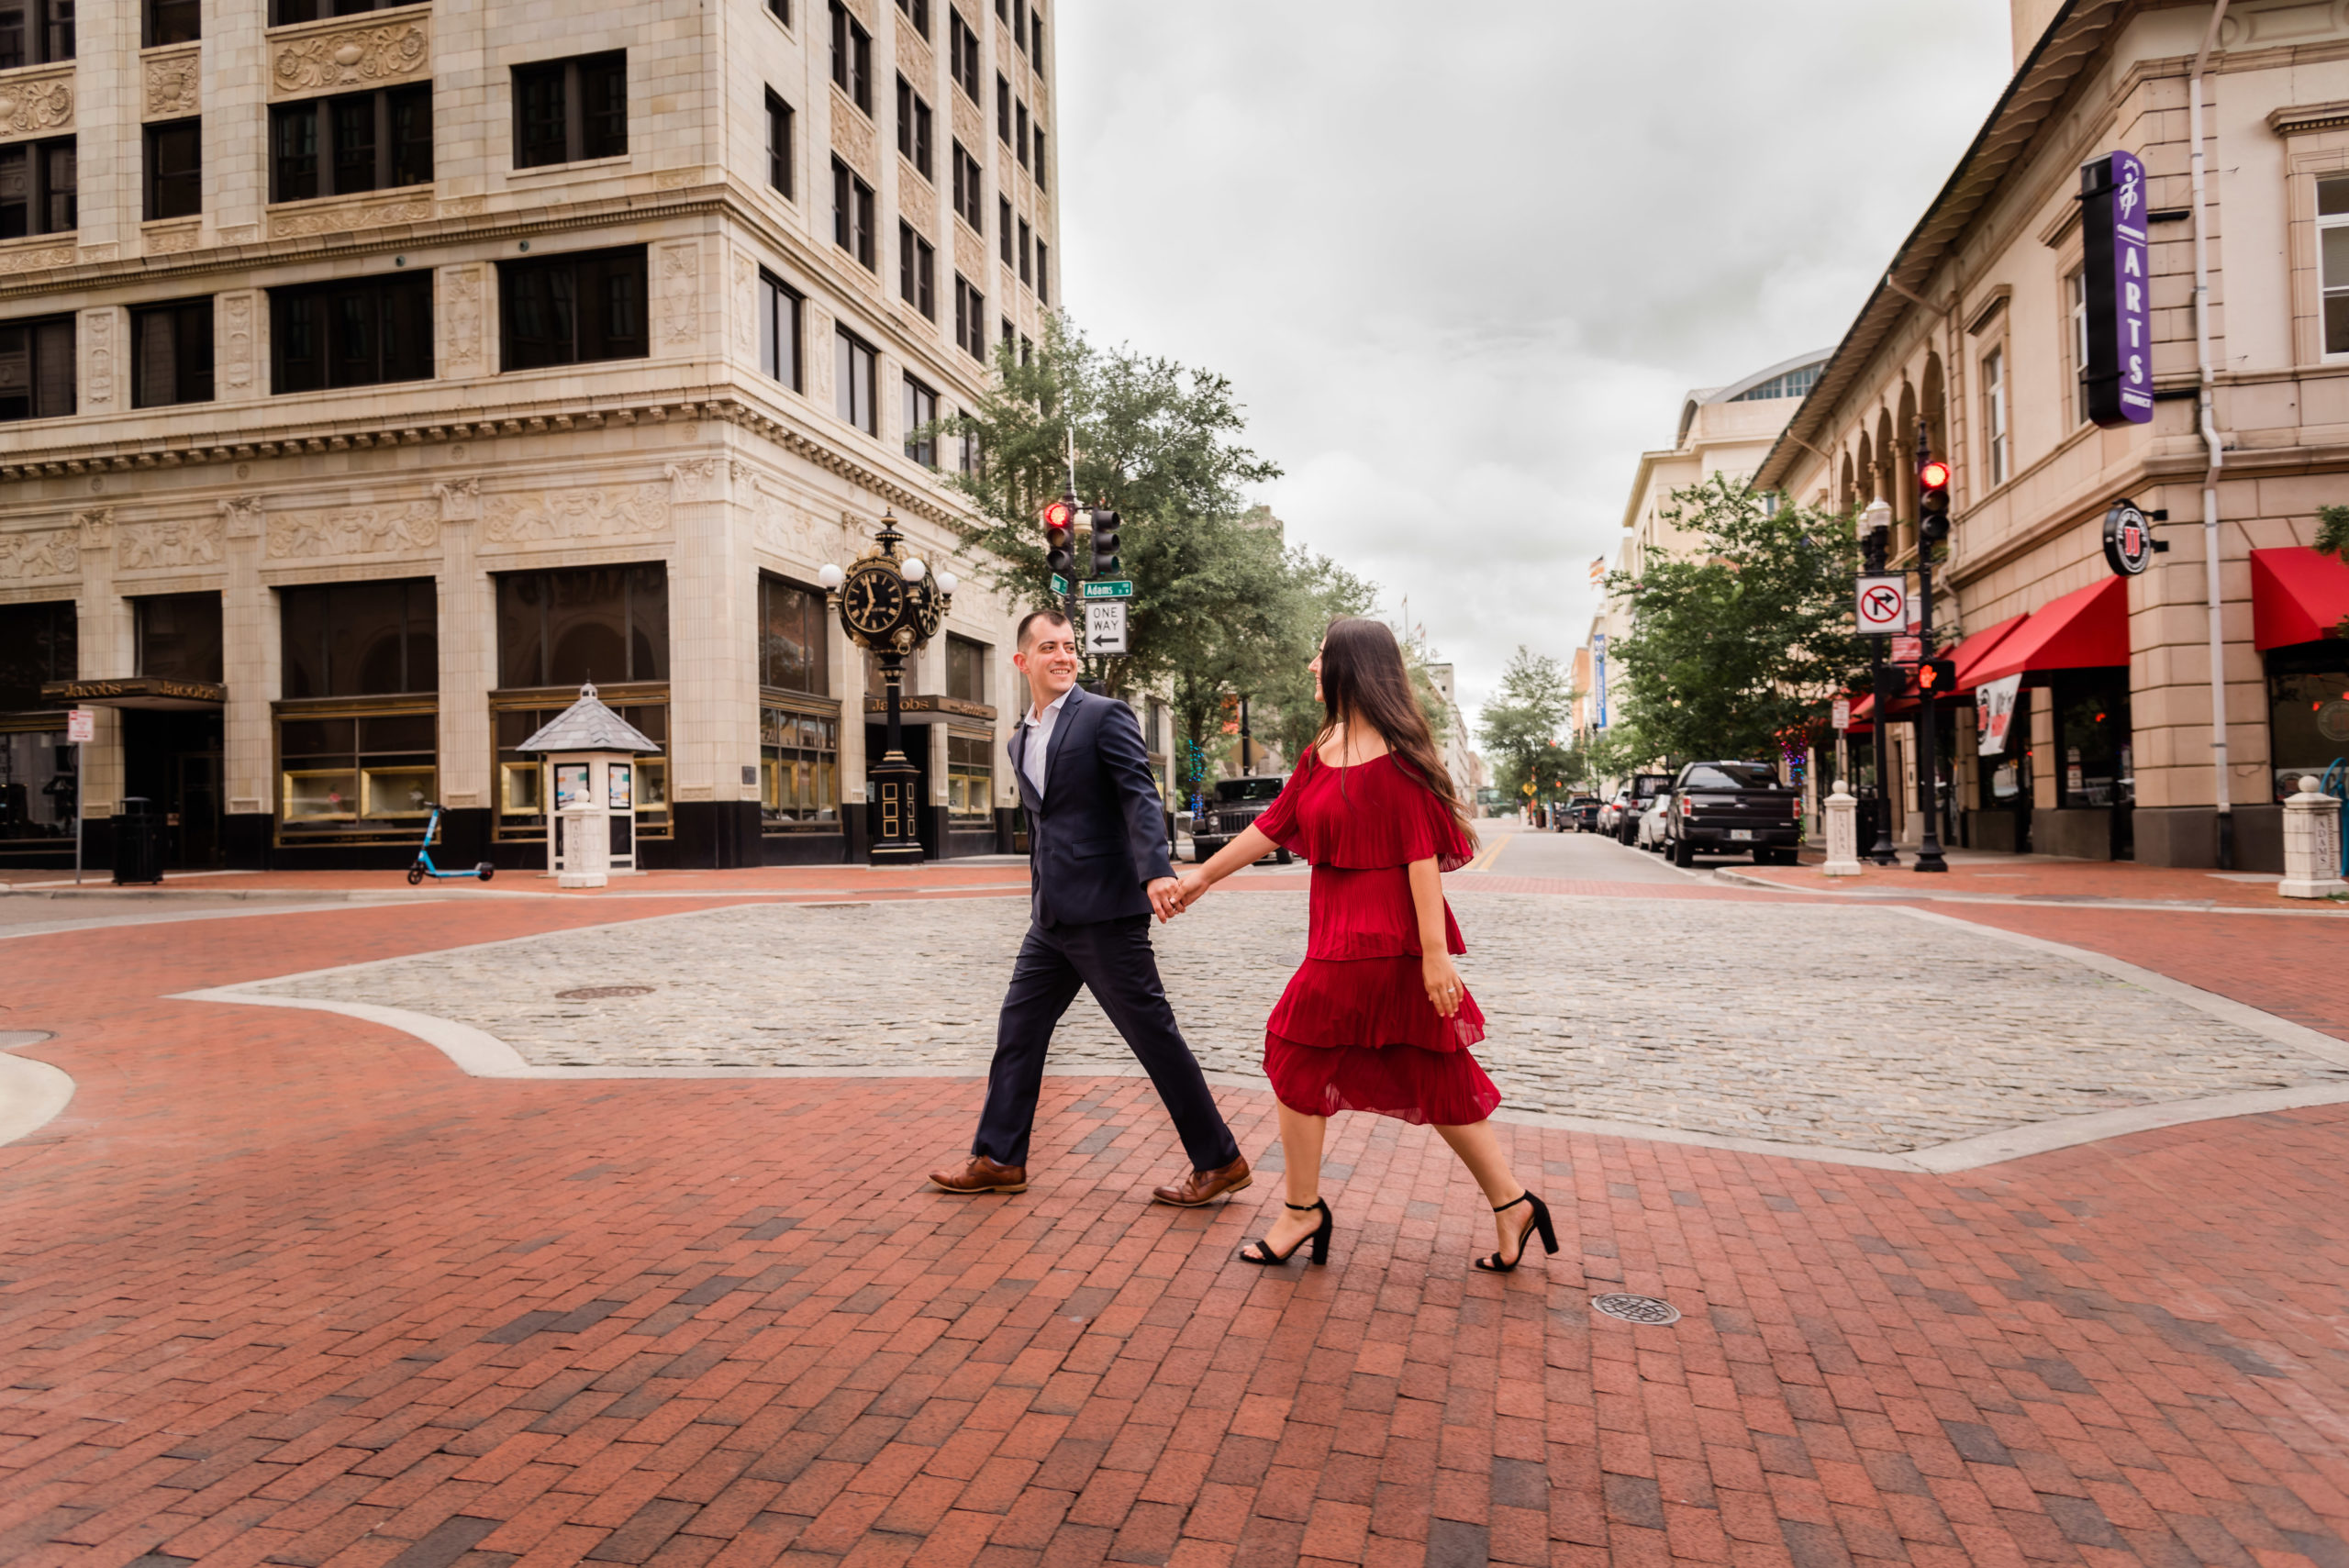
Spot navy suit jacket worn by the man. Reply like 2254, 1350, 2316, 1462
1010, 685, 1174, 925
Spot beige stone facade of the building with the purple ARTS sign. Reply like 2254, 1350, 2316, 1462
1759, 0, 2349, 871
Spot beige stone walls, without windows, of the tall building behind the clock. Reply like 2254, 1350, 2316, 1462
0, 0, 1060, 863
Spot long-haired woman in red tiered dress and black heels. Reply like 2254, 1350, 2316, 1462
1182, 617, 1557, 1273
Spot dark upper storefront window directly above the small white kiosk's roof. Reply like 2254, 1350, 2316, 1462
498, 561, 670, 688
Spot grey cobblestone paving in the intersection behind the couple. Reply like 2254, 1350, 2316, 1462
253, 887, 2349, 1152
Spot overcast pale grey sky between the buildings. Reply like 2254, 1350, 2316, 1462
1052, 0, 2010, 716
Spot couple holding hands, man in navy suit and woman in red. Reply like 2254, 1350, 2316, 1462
930, 610, 1557, 1273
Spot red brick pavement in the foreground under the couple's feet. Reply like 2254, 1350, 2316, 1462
0, 899, 2349, 1568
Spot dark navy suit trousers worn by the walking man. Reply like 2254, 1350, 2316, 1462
970, 916, 1241, 1172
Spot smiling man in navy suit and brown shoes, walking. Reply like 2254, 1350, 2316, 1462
930, 610, 1250, 1209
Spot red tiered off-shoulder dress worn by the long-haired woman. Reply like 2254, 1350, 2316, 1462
1257, 751, 1501, 1127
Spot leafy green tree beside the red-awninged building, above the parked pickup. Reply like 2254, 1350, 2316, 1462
1607, 474, 1867, 762
